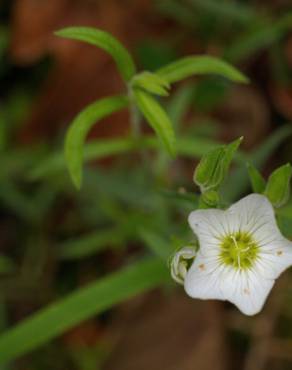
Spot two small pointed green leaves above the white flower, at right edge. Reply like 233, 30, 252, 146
248, 163, 292, 208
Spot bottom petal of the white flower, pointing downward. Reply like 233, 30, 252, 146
222, 269, 275, 316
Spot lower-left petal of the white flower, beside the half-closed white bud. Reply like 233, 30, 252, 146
184, 253, 224, 300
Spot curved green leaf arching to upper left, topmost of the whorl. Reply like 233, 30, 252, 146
55, 27, 136, 82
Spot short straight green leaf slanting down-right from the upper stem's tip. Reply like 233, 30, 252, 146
133, 89, 176, 156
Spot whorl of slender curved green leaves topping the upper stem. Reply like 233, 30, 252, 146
56, 27, 248, 188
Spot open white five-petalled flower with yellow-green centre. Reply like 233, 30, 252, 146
184, 194, 292, 315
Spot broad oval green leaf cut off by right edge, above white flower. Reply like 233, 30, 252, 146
265, 163, 292, 208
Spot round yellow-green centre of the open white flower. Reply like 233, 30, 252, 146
220, 231, 259, 269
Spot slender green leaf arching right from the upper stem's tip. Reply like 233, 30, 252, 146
156, 55, 248, 83
